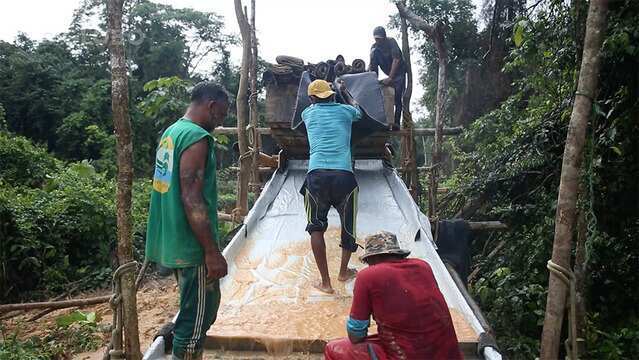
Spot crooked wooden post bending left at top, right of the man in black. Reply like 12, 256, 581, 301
395, 2, 448, 219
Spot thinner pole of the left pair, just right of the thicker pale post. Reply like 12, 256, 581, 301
249, 0, 261, 198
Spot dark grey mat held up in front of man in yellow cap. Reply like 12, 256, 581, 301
291, 71, 387, 143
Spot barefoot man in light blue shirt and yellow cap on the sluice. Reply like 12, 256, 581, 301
300, 80, 362, 293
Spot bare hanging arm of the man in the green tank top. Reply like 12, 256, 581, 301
180, 139, 227, 279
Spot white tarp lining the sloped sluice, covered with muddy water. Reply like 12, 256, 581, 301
145, 160, 501, 360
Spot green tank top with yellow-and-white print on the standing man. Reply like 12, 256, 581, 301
146, 118, 219, 268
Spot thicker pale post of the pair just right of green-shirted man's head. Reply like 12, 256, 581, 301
234, 0, 251, 216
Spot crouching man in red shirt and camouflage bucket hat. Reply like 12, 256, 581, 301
324, 231, 462, 360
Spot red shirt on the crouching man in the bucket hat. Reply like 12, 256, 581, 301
351, 259, 462, 360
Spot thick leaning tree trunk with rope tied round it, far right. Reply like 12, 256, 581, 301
541, 0, 608, 359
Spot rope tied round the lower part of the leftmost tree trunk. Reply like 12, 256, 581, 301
103, 261, 139, 360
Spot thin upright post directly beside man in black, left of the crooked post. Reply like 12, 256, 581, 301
400, 0, 419, 202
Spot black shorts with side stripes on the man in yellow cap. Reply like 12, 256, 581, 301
300, 169, 359, 252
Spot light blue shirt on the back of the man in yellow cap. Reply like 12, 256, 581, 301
302, 102, 361, 172
